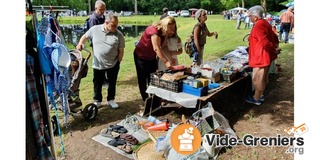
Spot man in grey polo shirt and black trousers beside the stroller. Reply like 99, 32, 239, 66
77, 14, 125, 108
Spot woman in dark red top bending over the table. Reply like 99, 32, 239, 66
133, 16, 176, 101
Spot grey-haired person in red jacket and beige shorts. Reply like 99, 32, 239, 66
245, 6, 281, 105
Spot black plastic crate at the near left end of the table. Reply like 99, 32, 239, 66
150, 72, 182, 92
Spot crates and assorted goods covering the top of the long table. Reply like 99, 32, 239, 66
148, 46, 248, 97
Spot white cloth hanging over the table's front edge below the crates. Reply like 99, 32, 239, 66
146, 86, 199, 108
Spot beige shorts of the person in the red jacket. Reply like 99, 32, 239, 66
252, 67, 269, 92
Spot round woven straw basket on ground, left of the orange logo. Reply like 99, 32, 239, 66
132, 141, 165, 160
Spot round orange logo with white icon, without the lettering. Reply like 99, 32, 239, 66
170, 124, 201, 155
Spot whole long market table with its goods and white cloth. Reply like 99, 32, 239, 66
144, 46, 249, 115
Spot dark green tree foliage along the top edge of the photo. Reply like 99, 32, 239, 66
32, 0, 290, 14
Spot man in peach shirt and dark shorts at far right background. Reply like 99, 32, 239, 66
279, 7, 294, 43
